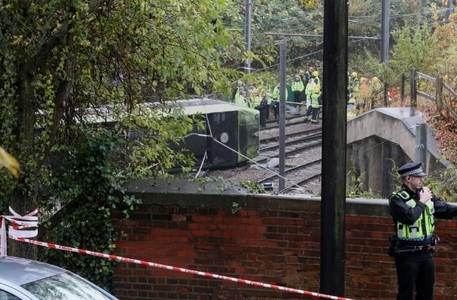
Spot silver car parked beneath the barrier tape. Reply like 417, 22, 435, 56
0, 256, 117, 300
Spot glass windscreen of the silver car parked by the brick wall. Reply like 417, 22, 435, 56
22, 273, 109, 300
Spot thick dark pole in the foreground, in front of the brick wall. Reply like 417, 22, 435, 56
320, 0, 348, 296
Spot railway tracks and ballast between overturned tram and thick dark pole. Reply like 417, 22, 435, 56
205, 115, 322, 195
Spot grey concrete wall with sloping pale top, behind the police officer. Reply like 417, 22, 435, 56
347, 107, 448, 197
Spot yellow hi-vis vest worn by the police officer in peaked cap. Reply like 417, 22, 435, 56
394, 191, 435, 241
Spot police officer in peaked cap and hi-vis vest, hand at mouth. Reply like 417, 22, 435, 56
389, 163, 457, 300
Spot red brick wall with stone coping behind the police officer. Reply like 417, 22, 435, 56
109, 179, 457, 300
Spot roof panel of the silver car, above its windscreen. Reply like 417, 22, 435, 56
0, 256, 66, 285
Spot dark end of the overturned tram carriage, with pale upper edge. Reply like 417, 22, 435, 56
177, 99, 260, 169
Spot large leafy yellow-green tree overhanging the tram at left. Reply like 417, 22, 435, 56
0, 0, 244, 288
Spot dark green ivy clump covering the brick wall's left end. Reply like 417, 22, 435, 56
40, 130, 139, 290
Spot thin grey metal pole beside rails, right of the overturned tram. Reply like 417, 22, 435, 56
279, 40, 286, 192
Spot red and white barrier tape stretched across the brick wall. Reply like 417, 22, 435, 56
0, 208, 351, 300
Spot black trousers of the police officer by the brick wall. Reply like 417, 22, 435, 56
395, 252, 435, 300
